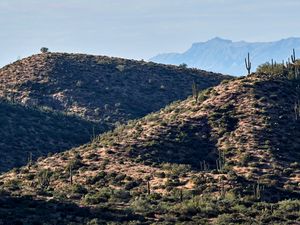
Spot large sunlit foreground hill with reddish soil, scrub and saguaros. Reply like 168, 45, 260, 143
0, 69, 300, 224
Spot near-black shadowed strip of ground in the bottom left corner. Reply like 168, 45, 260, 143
0, 194, 144, 225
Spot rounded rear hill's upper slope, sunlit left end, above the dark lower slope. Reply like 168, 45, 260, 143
0, 53, 229, 123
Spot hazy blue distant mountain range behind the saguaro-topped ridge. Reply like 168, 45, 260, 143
150, 37, 300, 76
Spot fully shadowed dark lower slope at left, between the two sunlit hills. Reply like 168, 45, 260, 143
0, 101, 104, 172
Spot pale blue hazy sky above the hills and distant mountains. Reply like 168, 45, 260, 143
0, 0, 300, 66
